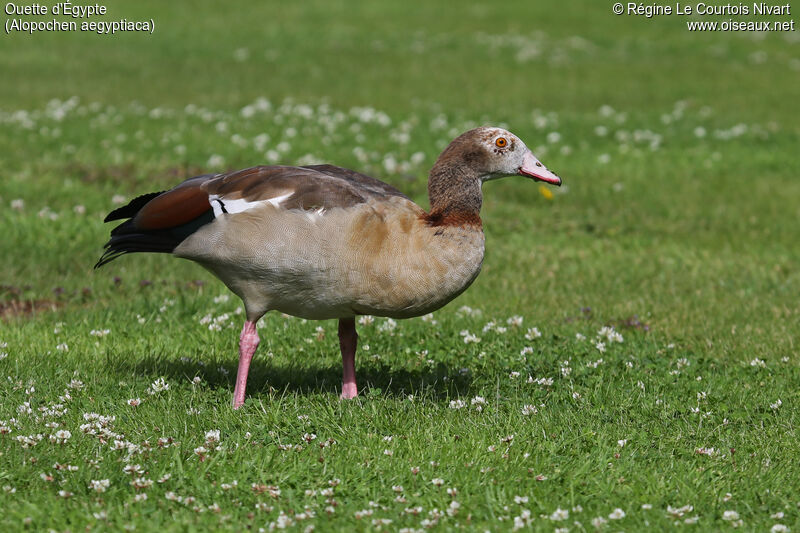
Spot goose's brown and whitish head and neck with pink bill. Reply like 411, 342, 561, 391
428, 127, 561, 225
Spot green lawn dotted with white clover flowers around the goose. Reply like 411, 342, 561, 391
0, 1, 800, 531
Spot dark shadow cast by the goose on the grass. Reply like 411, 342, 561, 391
107, 356, 472, 400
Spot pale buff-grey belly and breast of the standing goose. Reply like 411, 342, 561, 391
175, 203, 484, 319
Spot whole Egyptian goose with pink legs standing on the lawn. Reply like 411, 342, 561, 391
95, 127, 561, 408
